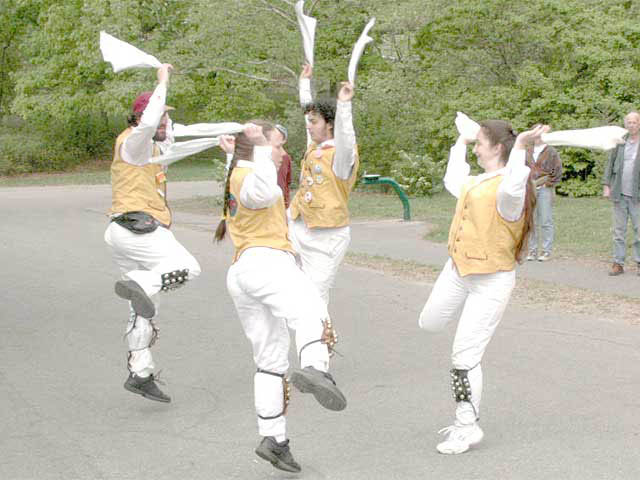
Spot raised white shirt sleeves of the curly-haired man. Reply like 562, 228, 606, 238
300, 78, 356, 180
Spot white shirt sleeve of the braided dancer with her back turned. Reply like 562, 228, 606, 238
236, 145, 282, 210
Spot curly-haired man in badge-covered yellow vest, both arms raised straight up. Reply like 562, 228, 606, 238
289, 64, 359, 312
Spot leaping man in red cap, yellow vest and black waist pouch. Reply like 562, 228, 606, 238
104, 64, 200, 402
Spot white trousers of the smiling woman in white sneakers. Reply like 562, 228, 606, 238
418, 258, 516, 425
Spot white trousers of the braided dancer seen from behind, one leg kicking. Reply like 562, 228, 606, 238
227, 247, 329, 440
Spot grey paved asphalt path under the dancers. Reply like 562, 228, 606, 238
0, 183, 640, 480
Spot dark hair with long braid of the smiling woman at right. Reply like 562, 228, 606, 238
480, 120, 536, 263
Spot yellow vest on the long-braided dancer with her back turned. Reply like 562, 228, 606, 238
226, 167, 294, 262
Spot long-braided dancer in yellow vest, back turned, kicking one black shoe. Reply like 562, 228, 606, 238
216, 122, 347, 472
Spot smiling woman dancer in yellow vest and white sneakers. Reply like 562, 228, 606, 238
419, 120, 548, 454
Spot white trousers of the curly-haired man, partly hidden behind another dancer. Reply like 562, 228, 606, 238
289, 217, 351, 305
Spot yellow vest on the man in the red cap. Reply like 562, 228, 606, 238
109, 128, 171, 226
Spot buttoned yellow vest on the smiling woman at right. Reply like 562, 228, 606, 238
448, 175, 524, 277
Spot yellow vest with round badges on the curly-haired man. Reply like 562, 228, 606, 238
290, 144, 360, 228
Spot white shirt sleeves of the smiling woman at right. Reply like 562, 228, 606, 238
444, 142, 530, 222
